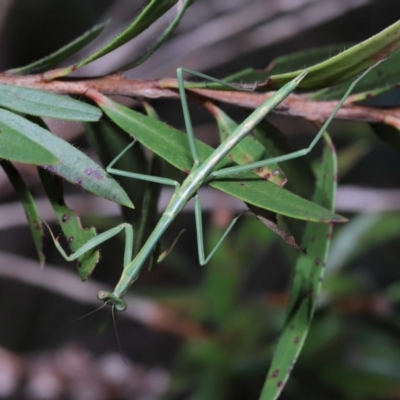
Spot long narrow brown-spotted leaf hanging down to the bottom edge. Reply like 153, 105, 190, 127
260, 134, 337, 400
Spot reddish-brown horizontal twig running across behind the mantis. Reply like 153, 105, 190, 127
0, 73, 400, 128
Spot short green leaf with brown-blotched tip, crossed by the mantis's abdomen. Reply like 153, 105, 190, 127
204, 102, 287, 186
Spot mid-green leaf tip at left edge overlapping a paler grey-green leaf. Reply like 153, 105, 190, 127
0, 121, 58, 165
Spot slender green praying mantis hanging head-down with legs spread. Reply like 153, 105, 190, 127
50, 66, 374, 311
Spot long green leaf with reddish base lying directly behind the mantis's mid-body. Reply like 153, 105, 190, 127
87, 91, 346, 222
